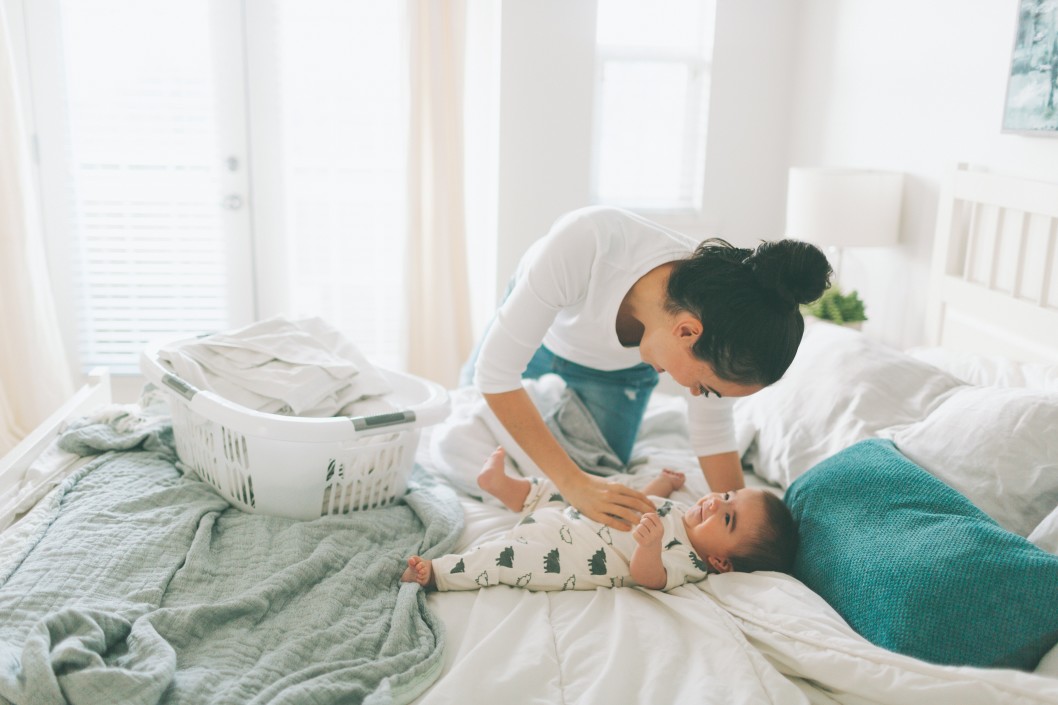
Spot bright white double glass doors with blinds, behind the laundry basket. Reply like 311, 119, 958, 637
25, 0, 406, 374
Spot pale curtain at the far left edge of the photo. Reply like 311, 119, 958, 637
0, 2, 73, 454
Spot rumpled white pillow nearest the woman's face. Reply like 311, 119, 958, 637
734, 322, 961, 487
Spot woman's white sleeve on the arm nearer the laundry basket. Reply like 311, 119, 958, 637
474, 211, 598, 394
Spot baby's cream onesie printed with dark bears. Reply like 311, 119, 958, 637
433, 478, 708, 591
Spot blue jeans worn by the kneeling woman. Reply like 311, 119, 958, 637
460, 336, 658, 465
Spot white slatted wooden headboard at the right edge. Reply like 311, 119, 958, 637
927, 165, 1058, 364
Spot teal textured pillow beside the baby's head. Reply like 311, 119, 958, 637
786, 439, 1058, 670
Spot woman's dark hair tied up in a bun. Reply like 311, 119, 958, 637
667, 238, 833, 386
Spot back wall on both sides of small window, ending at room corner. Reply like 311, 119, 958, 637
490, 0, 797, 292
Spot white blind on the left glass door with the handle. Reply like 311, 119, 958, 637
56, 0, 248, 373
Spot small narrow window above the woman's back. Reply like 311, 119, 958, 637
592, 0, 715, 212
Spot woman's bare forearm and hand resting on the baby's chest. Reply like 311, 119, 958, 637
484, 388, 654, 531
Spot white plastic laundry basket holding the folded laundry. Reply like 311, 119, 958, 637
140, 338, 449, 520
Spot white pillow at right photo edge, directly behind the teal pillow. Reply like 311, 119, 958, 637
884, 386, 1058, 536
